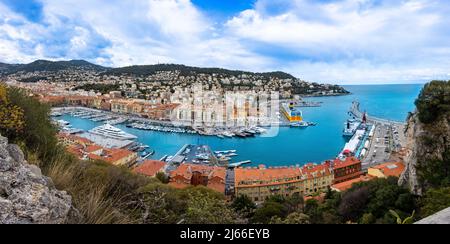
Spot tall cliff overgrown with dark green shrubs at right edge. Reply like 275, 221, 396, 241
405, 81, 450, 217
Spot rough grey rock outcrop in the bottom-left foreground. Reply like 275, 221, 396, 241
0, 135, 72, 224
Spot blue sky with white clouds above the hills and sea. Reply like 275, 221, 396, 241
0, 0, 450, 84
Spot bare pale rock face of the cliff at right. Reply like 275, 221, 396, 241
399, 113, 450, 195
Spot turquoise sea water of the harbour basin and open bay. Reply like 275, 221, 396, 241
62, 84, 422, 166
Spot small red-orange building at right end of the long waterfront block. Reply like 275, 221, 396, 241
332, 157, 363, 184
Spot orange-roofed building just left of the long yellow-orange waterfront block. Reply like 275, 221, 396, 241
169, 163, 226, 193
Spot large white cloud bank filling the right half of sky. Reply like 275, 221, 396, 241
226, 0, 450, 83
